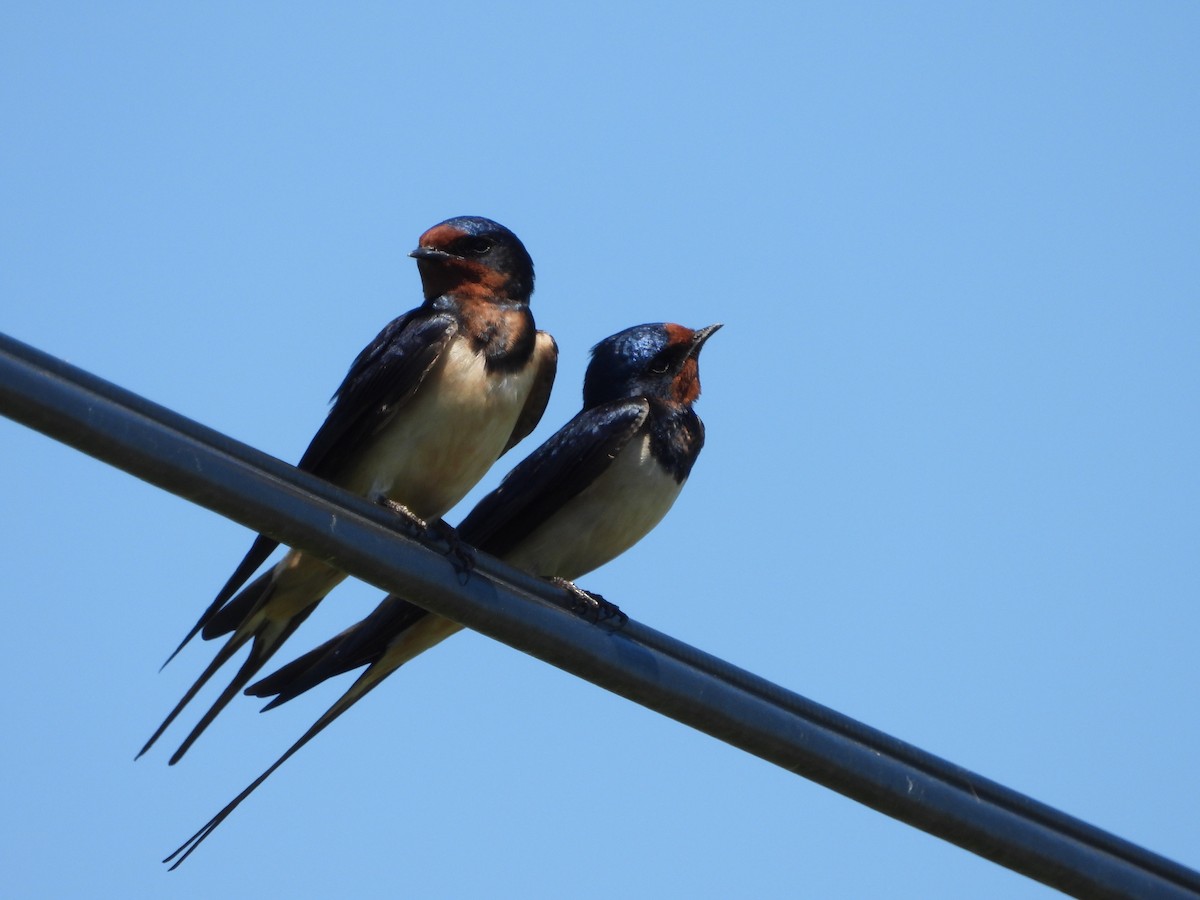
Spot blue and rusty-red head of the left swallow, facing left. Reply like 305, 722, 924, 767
409, 216, 533, 304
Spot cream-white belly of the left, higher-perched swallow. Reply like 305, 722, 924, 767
343, 337, 535, 518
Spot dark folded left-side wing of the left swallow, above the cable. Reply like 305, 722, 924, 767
298, 306, 458, 481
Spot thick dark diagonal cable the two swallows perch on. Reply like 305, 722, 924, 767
0, 334, 1200, 898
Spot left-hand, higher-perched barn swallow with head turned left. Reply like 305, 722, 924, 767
138, 216, 558, 764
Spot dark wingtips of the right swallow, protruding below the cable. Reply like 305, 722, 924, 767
246, 594, 430, 709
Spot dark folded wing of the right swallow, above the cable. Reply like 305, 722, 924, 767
458, 398, 650, 557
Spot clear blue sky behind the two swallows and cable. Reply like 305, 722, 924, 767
0, 2, 1200, 898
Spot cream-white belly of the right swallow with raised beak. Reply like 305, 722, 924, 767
504, 431, 683, 581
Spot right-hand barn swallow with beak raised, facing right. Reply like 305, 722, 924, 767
163, 324, 720, 869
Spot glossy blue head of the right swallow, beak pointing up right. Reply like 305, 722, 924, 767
583, 323, 720, 409
